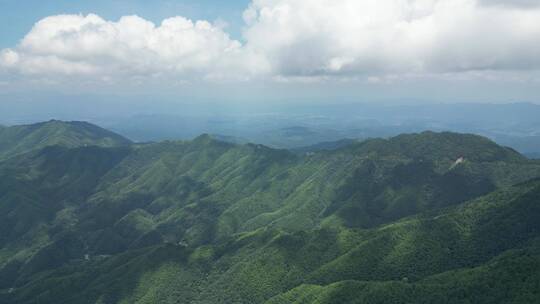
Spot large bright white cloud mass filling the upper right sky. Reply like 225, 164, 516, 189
244, 0, 540, 76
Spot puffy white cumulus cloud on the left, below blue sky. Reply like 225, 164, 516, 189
0, 14, 260, 81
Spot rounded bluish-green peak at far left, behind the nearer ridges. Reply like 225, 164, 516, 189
0, 120, 131, 158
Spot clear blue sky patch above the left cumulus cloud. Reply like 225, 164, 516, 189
0, 0, 250, 49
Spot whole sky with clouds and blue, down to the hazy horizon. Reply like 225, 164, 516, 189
0, 0, 540, 108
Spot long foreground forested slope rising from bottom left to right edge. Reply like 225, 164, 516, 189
4, 181, 540, 303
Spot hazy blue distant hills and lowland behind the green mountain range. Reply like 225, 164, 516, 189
64, 103, 540, 157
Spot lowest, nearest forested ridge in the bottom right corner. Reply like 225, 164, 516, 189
266, 246, 540, 304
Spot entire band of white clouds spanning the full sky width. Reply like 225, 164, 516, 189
0, 0, 540, 81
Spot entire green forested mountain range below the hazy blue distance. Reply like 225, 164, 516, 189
0, 122, 540, 303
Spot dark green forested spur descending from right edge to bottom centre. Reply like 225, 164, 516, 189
268, 181, 540, 303
